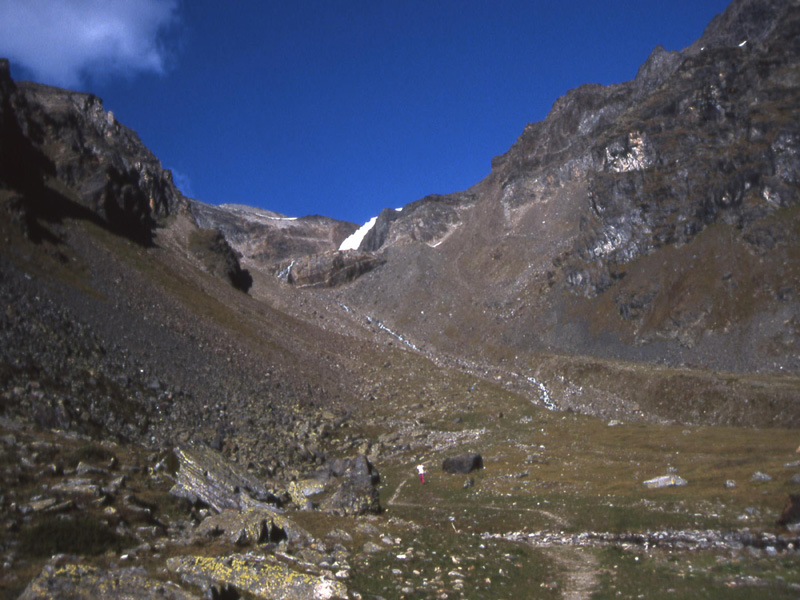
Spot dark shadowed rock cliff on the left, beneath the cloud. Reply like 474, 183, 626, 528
0, 60, 186, 240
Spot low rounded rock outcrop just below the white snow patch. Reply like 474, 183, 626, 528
278, 250, 384, 287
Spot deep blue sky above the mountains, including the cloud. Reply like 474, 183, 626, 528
0, 0, 728, 223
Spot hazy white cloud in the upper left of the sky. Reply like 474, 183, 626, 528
0, 0, 178, 87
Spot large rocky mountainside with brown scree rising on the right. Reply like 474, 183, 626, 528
330, 0, 800, 384
